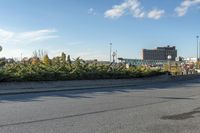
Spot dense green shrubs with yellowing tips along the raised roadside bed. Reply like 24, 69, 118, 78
0, 53, 166, 81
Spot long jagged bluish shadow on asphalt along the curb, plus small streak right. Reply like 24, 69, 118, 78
0, 79, 200, 103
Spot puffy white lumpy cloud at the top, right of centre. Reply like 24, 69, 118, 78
104, 0, 165, 19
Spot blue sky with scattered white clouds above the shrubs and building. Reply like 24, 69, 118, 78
0, 0, 200, 60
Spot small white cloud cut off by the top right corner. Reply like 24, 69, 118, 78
175, 0, 200, 17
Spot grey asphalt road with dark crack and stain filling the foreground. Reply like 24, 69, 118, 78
0, 80, 200, 133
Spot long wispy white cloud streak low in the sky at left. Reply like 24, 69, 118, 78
0, 29, 59, 45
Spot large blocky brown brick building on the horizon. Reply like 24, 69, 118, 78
142, 45, 177, 61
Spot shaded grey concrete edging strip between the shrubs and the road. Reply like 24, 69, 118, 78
0, 75, 200, 95
